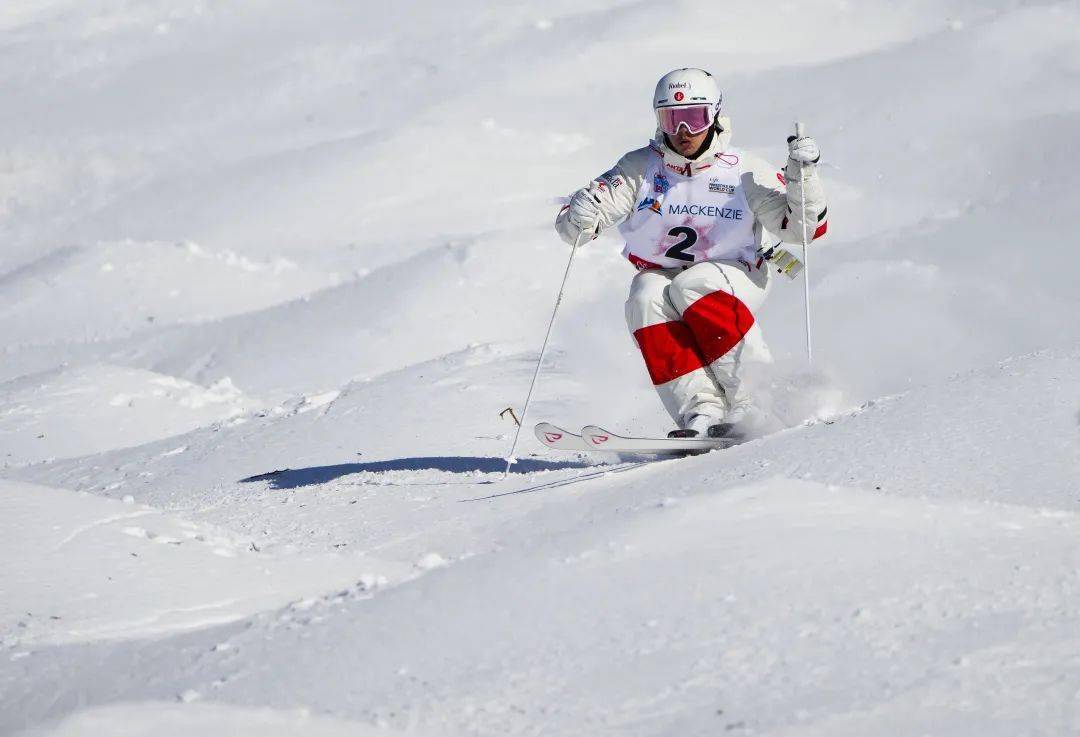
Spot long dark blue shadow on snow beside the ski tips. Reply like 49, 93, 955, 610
241, 456, 590, 488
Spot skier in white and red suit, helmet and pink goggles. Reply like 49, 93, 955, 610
555, 68, 827, 441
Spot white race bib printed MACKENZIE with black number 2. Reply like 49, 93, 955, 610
619, 144, 757, 269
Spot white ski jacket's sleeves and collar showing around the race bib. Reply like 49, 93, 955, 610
555, 116, 828, 258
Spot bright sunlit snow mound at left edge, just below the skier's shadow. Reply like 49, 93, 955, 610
0, 481, 386, 648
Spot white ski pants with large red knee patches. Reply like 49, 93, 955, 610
626, 260, 769, 427
